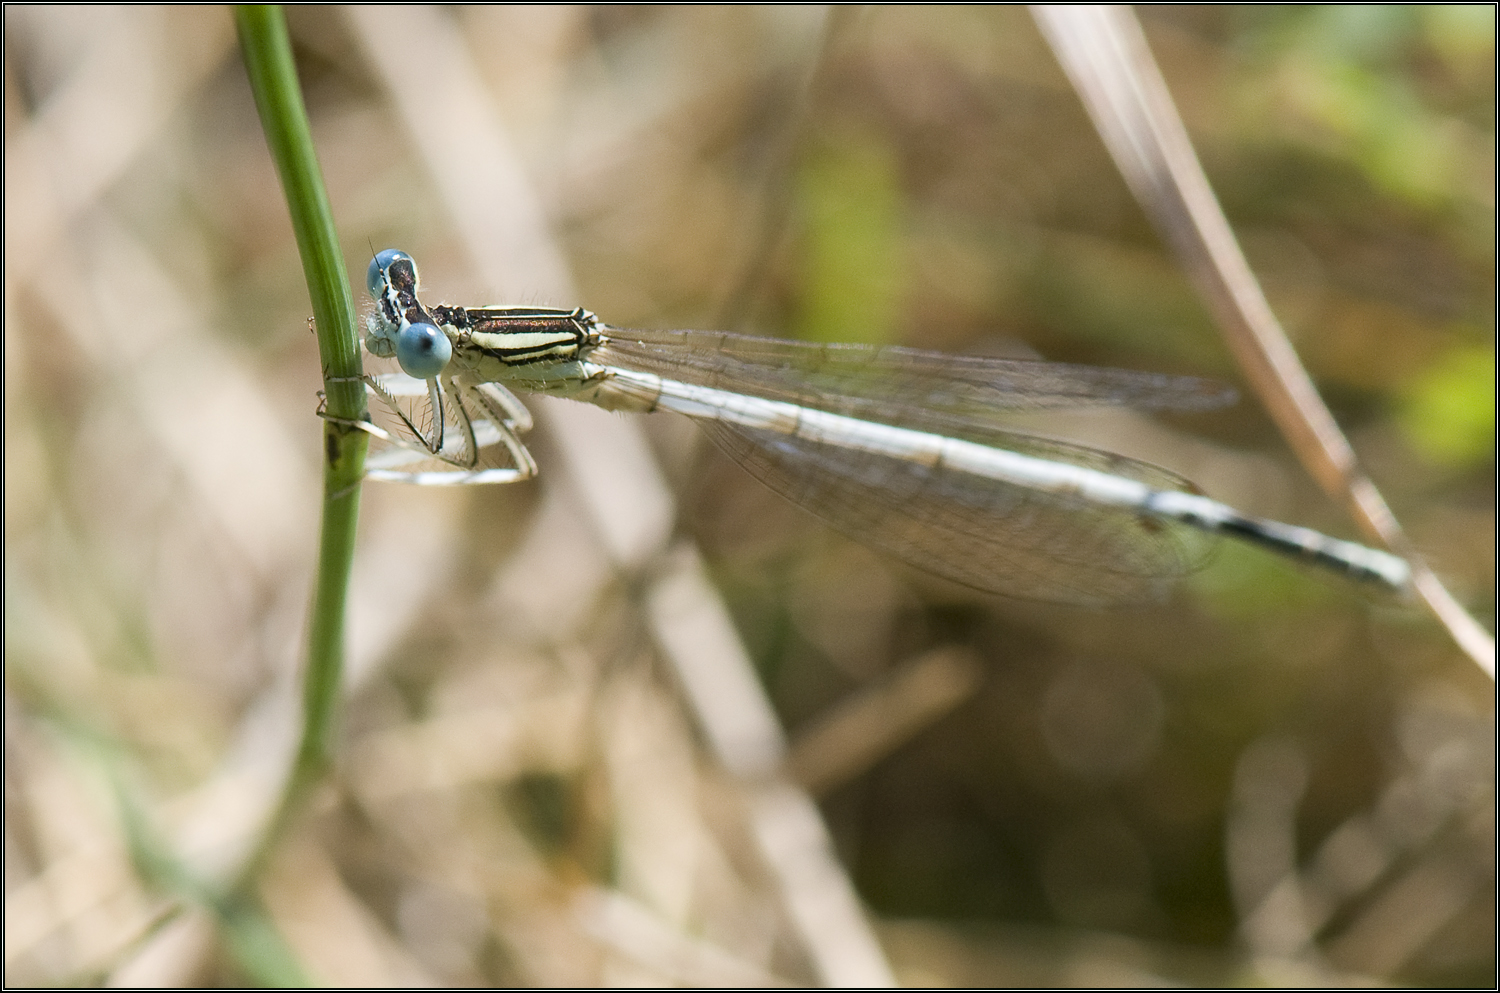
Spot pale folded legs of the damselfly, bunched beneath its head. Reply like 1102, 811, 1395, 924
365, 357, 537, 486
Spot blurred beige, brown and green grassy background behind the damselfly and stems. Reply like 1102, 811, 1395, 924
5, 6, 1496, 986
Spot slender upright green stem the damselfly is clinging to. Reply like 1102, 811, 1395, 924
233, 6, 368, 893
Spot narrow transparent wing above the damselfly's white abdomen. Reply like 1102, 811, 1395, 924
591, 327, 1235, 434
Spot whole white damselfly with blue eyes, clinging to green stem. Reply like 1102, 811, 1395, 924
334, 249, 1410, 603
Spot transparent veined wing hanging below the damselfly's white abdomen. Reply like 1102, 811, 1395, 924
699, 420, 1215, 606
